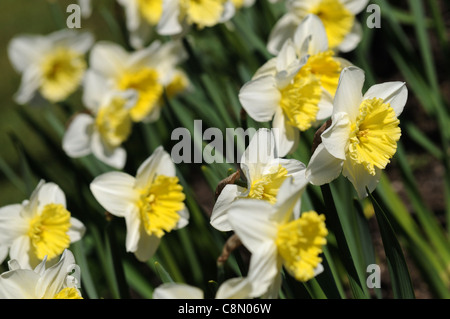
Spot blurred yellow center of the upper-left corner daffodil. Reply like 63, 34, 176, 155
41, 47, 86, 102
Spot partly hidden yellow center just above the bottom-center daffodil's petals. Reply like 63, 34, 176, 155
248, 165, 288, 204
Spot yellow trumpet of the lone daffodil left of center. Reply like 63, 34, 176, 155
139, 175, 185, 238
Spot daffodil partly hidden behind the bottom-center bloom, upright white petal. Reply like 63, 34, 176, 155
210, 129, 305, 231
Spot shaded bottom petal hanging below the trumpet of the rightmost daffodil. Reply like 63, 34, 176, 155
342, 161, 381, 198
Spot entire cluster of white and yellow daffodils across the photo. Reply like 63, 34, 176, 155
0, 0, 408, 299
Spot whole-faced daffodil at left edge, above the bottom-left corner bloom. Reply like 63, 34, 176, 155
0, 181, 85, 268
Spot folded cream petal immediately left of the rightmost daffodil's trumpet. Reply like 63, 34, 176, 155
321, 113, 351, 160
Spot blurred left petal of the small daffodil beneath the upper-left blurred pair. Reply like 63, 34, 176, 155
62, 114, 94, 158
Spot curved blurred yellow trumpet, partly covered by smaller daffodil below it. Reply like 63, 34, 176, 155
118, 68, 163, 122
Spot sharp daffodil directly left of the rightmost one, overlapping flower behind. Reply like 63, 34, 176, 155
239, 39, 332, 157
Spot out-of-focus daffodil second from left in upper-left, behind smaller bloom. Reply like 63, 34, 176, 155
85, 41, 189, 122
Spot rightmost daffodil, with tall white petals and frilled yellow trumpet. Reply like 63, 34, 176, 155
306, 67, 408, 198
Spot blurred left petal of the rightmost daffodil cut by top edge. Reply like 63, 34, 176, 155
267, 13, 301, 55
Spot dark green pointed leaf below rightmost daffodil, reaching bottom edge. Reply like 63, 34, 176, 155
367, 190, 415, 299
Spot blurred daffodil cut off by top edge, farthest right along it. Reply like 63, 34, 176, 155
267, 0, 369, 55
